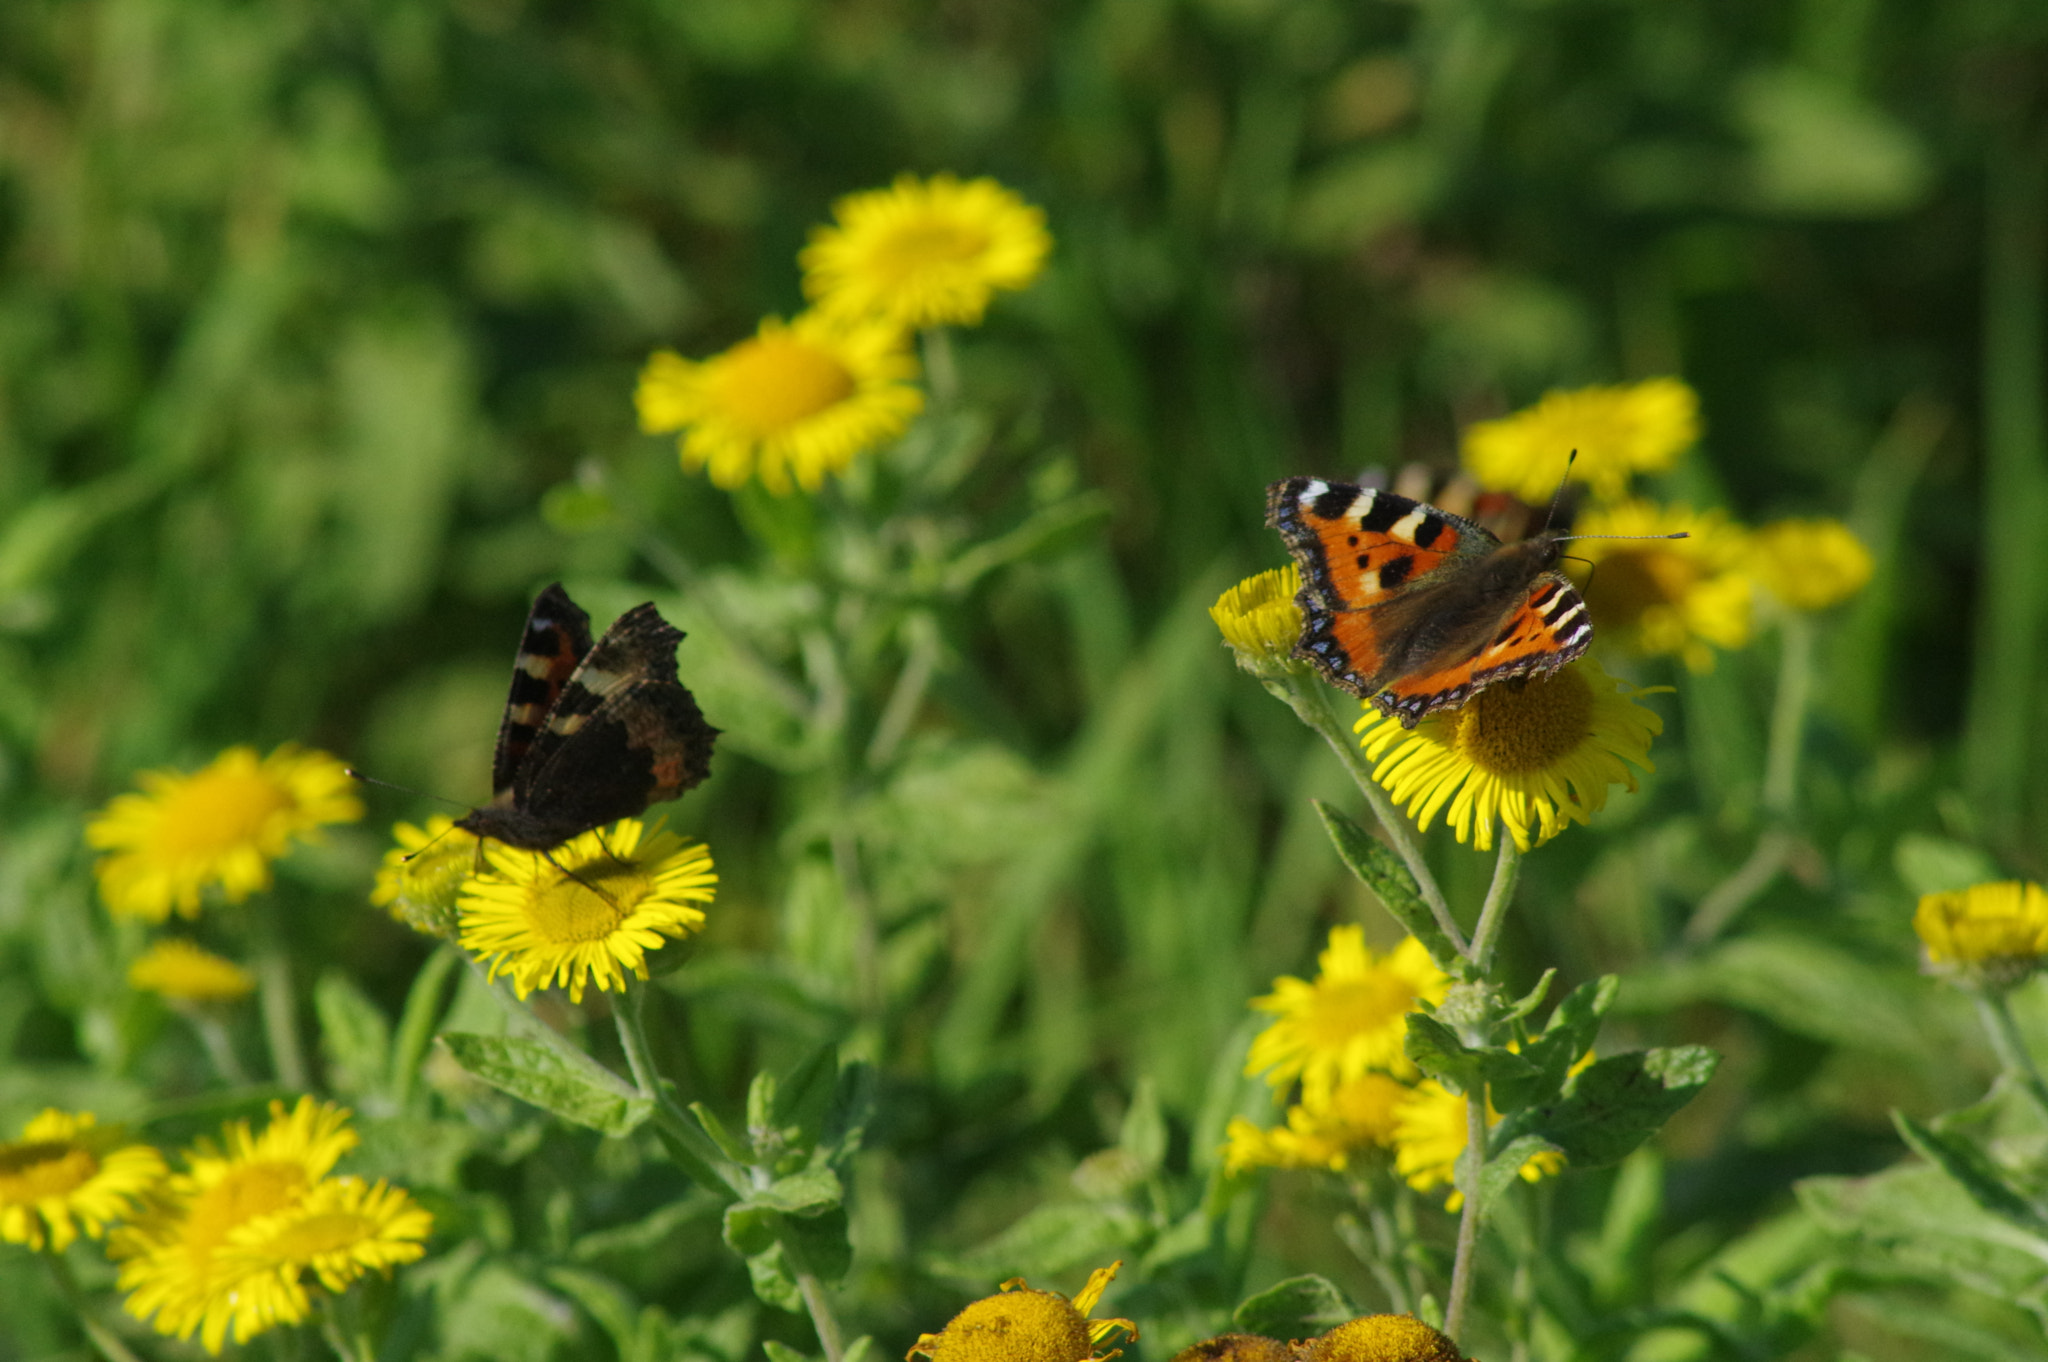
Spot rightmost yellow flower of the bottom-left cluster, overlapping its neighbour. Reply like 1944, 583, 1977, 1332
221, 1178, 434, 1327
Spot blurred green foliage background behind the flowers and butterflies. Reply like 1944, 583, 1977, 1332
12, 0, 2048, 1362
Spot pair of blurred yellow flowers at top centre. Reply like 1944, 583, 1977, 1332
633, 174, 1053, 496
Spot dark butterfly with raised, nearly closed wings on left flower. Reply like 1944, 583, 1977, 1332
457, 582, 719, 852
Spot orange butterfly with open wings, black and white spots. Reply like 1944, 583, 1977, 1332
1266, 477, 1593, 729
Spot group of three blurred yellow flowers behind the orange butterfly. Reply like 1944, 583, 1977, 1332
1462, 377, 1872, 672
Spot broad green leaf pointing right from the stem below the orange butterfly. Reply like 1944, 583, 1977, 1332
1501, 1045, 1720, 1167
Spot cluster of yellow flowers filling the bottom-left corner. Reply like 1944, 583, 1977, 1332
0, 1098, 434, 1354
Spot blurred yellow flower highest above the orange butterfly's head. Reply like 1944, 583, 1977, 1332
1464, 379, 1700, 506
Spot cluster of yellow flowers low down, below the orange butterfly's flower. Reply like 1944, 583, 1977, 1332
1223, 926, 1591, 1210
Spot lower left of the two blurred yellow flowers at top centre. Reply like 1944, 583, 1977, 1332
633, 311, 924, 496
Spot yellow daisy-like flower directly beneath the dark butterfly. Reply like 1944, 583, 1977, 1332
461, 817, 719, 1002
